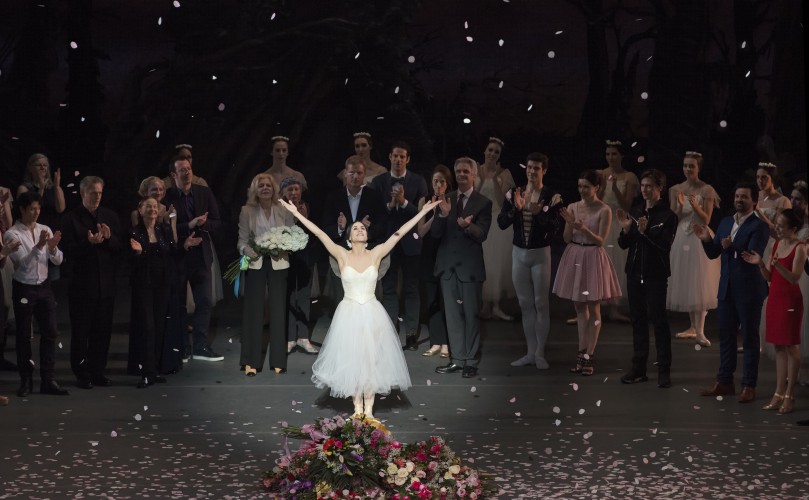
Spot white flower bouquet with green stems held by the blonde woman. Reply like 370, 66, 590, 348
222, 226, 309, 284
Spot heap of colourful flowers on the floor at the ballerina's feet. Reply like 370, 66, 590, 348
262, 416, 493, 500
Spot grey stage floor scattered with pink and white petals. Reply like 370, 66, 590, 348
0, 292, 809, 499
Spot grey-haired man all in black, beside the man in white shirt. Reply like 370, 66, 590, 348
62, 176, 122, 389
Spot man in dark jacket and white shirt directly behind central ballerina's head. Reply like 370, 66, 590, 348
320, 155, 387, 303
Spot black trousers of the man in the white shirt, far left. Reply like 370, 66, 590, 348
11, 280, 58, 382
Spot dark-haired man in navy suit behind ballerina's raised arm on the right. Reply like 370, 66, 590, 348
371, 141, 427, 351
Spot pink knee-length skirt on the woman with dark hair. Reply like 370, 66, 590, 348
553, 243, 621, 302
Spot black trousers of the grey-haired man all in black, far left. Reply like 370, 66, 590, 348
68, 290, 115, 379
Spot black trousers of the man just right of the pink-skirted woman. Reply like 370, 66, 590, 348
626, 276, 671, 374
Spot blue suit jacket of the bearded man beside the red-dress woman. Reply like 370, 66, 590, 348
702, 214, 770, 307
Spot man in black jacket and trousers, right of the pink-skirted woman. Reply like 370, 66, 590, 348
617, 169, 677, 388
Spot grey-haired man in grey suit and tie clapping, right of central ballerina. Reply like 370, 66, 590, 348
430, 158, 492, 378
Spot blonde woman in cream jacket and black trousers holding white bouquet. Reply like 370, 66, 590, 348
237, 173, 295, 377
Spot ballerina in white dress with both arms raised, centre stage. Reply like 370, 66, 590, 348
281, 200, 438, 418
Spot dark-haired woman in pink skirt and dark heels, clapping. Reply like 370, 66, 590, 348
553, 170, 621, 375
